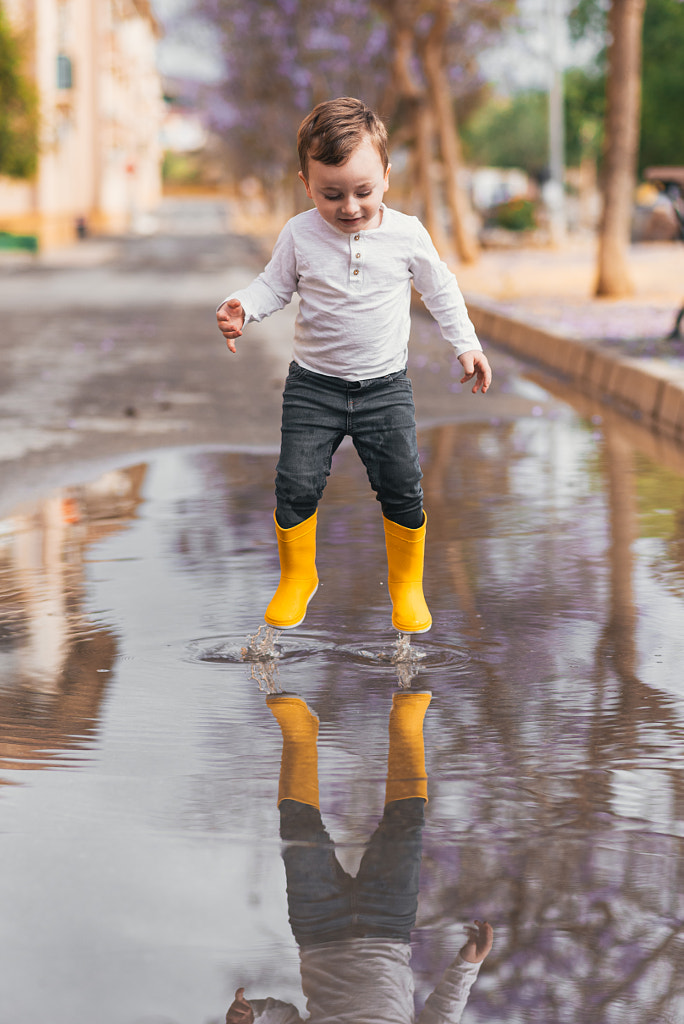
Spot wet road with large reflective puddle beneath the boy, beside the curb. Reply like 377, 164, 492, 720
0, 197, 684, 1024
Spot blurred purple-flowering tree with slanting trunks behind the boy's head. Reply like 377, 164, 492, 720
194, 0, 515, 259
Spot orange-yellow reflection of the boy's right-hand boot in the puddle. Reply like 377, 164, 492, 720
385, 690, 432, 804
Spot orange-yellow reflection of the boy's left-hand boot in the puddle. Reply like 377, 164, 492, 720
266, 693, 319, 807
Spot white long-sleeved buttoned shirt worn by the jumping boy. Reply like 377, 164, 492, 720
228, 205, 481, 381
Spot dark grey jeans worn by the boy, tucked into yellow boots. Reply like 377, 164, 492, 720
275, 361, 423, 529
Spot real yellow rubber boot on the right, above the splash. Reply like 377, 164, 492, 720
383, 512, 432, 633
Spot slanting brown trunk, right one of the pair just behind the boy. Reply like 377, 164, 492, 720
421, 0, 479, 263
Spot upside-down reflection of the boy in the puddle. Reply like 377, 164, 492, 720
226, 692, 493, 1024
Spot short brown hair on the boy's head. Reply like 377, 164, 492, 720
297, 96, 389, 177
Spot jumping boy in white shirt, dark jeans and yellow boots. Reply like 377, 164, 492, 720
216, 97, 491, 633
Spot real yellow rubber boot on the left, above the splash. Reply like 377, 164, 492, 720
264, 512, 318, 630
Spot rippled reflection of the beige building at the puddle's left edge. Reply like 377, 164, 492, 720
0, 466, 145, 770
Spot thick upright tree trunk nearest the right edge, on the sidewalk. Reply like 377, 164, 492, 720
596, 0, 646, 298
